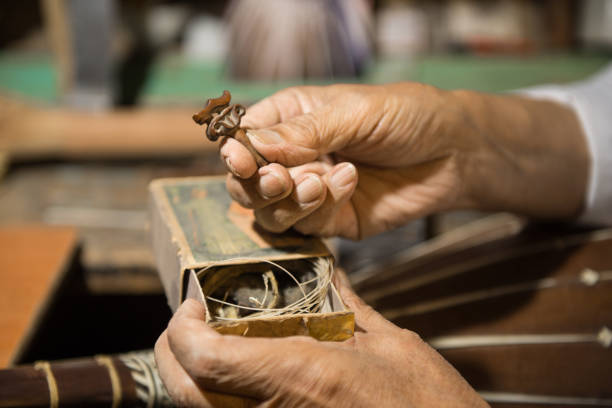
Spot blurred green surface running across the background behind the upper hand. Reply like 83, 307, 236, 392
0, 54, 610, 104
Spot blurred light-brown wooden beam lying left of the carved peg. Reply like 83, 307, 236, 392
0, 97, 217, 161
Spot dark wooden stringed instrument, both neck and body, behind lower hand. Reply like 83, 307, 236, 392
0, 220, 612, 408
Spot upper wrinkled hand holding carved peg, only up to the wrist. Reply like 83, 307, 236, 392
221, 83, 474, 239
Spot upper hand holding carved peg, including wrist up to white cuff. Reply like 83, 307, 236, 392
221, 83, 589, 239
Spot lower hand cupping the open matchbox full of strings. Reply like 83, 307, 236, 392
155, 272, 488, 408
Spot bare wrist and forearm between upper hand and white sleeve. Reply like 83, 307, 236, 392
452, 91, 590, 218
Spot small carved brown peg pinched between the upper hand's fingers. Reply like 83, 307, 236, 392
192, 91, 268, 167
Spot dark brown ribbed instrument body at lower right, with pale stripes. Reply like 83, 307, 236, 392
356, 225, 612, 407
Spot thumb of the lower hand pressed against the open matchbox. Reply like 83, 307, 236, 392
333, 268, 395, 332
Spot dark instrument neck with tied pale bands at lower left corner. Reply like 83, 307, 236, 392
0, 350, 174, 408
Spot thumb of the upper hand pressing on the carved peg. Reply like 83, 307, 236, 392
247, 105, 358, 166
